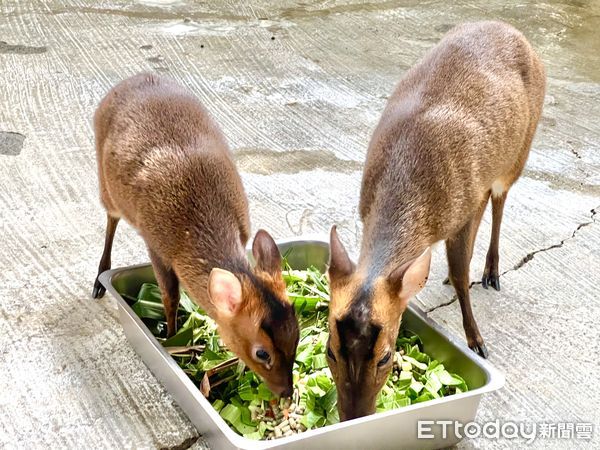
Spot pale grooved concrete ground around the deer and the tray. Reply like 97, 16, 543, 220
0, 0, 600, 449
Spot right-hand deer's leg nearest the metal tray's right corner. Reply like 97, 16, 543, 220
446, 193, 489, 358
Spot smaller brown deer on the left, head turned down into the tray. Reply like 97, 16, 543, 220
92, 74, 299, 396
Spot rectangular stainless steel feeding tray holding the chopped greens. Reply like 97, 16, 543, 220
100, 237, 504, 450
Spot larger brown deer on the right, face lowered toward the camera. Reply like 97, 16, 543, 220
328, 22, 545, 419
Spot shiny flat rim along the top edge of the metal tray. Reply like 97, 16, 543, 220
99, 235, 505, 449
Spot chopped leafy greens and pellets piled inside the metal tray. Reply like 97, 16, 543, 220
125, 264, 468, 439
